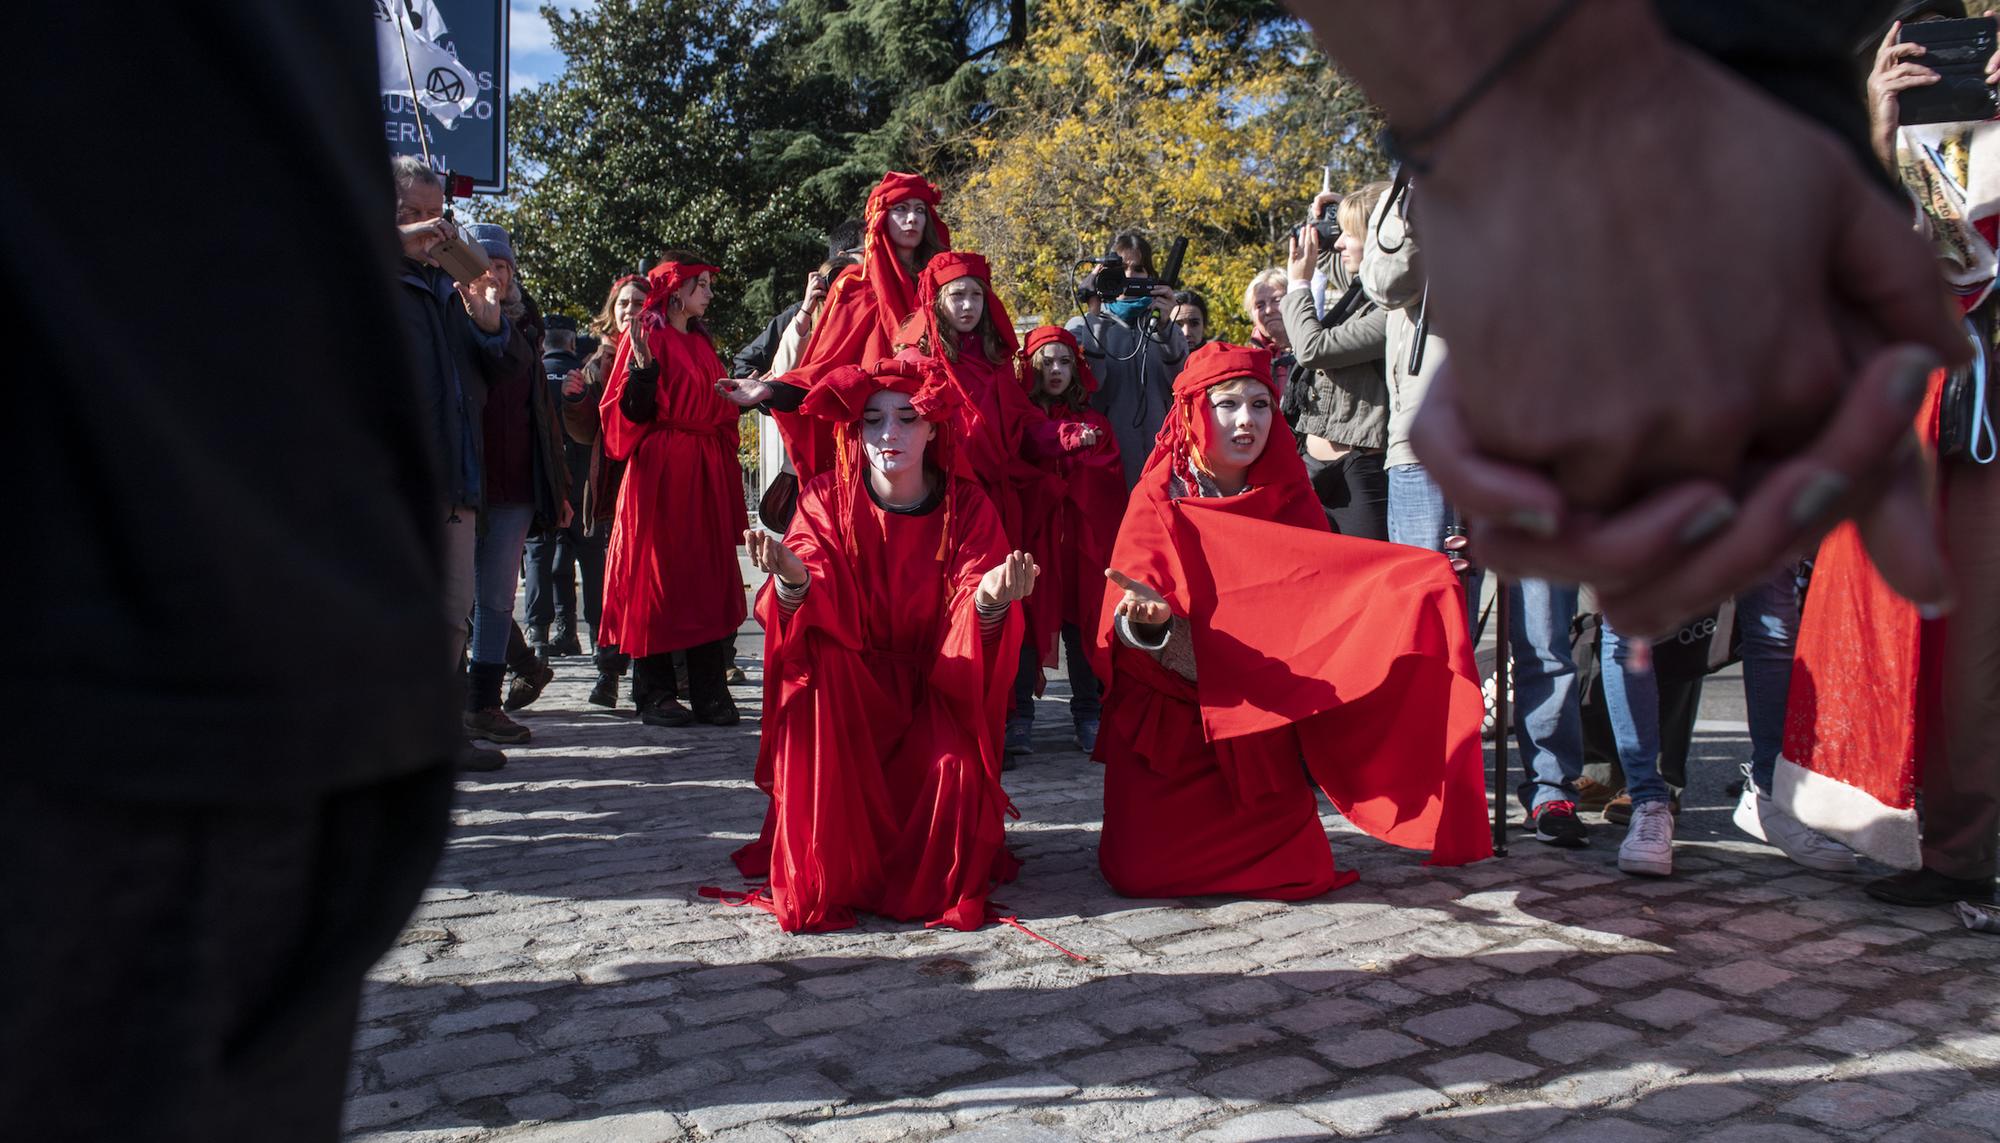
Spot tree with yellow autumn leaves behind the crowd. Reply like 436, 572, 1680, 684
950, 0, 1386, 340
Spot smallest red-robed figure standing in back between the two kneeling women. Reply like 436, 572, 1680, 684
1008, 326, 1126, 753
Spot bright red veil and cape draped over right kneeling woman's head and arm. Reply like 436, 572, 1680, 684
1096, 342, 1492, 865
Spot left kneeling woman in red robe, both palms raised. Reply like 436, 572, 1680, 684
736, 360, 1036, 931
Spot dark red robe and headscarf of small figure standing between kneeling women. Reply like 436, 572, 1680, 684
1020, 326, 1128, 679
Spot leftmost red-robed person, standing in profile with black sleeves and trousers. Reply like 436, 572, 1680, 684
600, 256, 748, 725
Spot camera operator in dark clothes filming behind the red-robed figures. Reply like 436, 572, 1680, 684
1064, 230, 1188, 488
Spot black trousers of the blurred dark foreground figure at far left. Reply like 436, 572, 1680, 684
0, 757, 452, 1143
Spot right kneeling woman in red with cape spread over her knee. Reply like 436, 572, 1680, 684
1096, 342, 1492, 899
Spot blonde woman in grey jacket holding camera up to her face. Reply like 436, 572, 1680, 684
1280, 182, 1388, 540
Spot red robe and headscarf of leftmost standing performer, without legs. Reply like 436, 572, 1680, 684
598, 324, 750, 655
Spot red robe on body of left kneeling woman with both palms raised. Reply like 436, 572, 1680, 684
736, 474, 1020, 931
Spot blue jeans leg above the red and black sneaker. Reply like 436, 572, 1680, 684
1506, 579, 1584, 809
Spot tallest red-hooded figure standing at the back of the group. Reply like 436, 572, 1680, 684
772, 170, 952, 484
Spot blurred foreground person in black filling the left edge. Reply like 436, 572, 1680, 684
0, 0, 458, 1143
